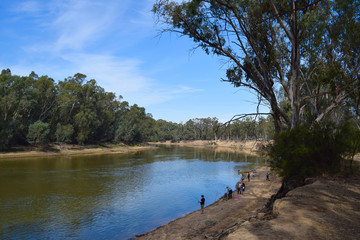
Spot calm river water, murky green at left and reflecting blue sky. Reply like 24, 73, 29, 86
0, 147, 264, 239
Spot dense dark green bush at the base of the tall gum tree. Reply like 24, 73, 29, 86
268, 123, 354, 177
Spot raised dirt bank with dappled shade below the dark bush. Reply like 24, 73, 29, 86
224, 174, 360, 240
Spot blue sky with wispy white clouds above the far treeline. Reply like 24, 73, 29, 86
0, 0, 268, 123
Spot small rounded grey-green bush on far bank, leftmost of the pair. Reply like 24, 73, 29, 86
27, 120, 50, 145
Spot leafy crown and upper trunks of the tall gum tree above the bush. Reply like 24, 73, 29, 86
153, 0, 360, 132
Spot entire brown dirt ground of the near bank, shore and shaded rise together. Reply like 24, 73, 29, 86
138, 167, 360, 240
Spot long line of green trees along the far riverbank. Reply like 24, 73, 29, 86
0, 69, 274, 149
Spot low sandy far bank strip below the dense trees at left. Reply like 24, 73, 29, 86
0, 144, 155, 159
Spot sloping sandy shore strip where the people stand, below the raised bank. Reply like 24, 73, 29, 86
135, 166, 281, 240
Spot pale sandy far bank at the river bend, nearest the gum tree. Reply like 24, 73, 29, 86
152, 140, 270, 155
